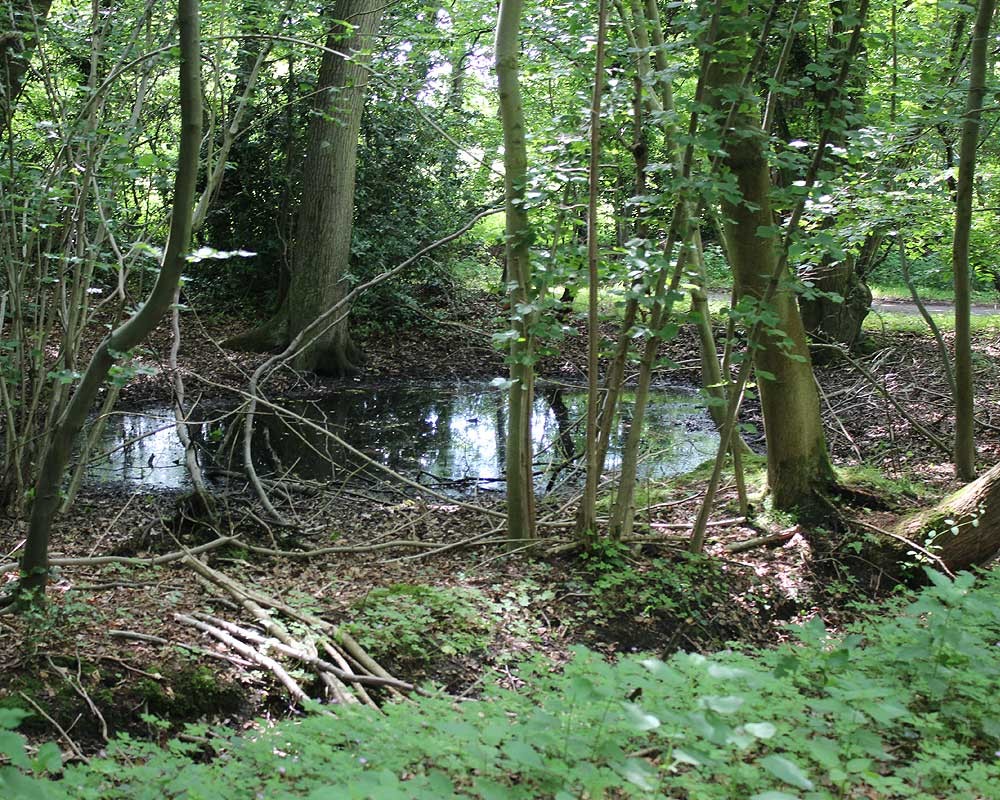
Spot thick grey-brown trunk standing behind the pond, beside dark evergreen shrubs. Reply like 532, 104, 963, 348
282, 0, 386, 375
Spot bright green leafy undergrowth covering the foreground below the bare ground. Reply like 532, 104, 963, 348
0, 572, 1000, 800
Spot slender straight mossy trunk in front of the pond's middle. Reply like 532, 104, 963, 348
496, 0, 536, 539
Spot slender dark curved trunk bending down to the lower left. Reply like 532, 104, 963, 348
19, 0, 202, 594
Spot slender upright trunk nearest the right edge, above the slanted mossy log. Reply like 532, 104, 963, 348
951, 0, 996, 481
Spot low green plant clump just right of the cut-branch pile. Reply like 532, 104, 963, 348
344, 583, 489, 674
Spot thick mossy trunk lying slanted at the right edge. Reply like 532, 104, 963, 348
896, 464, 1000, 570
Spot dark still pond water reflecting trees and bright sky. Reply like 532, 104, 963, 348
82, 384, 718, 491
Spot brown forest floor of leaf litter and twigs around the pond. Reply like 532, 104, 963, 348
0, 295, 1000, 756
